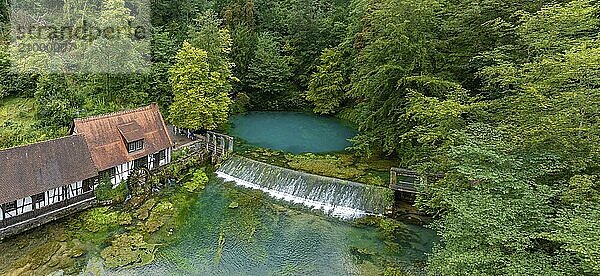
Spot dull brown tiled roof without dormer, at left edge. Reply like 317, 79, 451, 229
0, 135, 98, 204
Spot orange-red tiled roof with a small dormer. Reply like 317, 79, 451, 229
73, 103, 174, 171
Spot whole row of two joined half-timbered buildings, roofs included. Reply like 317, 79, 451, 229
0, 104, 174, 236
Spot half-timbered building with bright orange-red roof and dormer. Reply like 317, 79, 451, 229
72, 104, 174, 188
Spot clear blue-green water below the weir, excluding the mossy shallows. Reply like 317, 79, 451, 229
122, 179, 435, 275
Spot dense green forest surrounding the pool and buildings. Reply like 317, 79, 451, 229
0, 0, 600, 275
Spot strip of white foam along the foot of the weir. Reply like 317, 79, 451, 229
216, 172, 373, 219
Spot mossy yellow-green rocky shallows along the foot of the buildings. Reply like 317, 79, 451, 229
0, 152, 212, 275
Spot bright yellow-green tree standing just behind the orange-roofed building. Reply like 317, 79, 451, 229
168, 42, 231, 129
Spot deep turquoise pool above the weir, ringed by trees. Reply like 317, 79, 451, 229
231, 112, 357, 154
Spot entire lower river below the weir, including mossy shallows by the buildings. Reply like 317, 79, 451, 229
0, 140, 436, 275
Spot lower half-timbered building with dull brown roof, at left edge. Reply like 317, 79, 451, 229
0, 135, 98, 229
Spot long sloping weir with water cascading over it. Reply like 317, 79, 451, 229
217, 156, 393, 219
